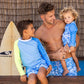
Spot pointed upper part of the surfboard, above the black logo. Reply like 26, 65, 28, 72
0, 21, 20, 52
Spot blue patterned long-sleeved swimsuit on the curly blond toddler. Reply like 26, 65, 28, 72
62, 21, 78, 47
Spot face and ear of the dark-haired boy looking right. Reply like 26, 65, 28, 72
24, 24, 35, 38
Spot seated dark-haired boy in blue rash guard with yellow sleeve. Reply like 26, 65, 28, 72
14, 20, 52, 84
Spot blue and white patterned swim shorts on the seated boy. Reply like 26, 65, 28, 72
26, 60, 48, 77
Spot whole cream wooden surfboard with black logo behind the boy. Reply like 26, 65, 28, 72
0, 21, 20, 75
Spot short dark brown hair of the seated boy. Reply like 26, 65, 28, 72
17, 20, 33, 37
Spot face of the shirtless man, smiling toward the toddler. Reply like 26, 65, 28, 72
44, 10, 56, 24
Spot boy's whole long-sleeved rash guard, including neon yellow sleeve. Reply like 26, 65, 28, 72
14, 37, 51, 75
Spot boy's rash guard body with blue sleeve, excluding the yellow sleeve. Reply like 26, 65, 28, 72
18, 37, 51, 67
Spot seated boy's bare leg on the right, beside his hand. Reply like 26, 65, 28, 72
37, 67, 48, 84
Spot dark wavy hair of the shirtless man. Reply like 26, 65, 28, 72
38, 2, 54, 14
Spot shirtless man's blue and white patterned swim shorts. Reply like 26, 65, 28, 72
48, 57, 77, 76
